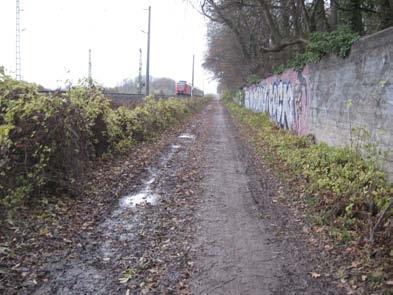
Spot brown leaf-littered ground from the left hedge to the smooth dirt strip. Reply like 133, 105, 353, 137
0, 107, 208, 294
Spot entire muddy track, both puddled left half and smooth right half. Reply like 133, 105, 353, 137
8, 102, 341, 294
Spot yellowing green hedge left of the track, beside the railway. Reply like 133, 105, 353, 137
0, 74, 205, 212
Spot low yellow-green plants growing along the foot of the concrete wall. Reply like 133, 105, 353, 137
227, 103, 393, 254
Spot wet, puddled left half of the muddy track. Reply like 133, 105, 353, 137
29, 107, 213, 294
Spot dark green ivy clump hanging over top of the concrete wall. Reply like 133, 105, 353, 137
273, 26, 359, 74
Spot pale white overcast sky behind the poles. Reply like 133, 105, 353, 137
0, 0, 216, 93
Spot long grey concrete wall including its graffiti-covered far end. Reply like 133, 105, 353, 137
244, 28, 393, 180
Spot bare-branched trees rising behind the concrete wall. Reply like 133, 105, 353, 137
199, 0, 393, 89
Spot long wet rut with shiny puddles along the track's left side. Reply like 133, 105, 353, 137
31, 133, 195, 294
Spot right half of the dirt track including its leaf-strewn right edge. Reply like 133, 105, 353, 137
191, 103, 342, 295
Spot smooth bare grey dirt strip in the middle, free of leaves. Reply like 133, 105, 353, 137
192, 105, 277, 294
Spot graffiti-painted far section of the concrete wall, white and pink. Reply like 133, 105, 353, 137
244, 67, 309, 134
